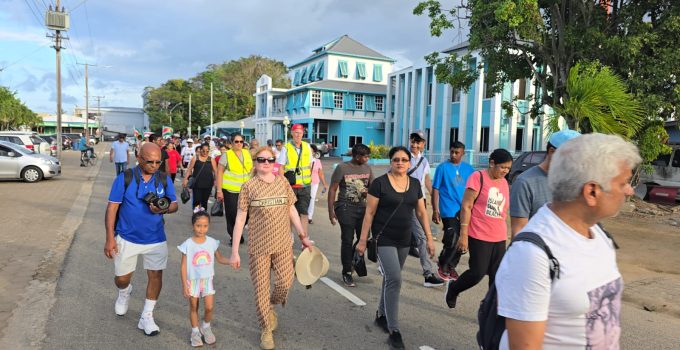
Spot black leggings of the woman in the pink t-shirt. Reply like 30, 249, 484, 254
450, 237, 505, 295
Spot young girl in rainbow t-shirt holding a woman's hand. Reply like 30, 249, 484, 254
177, 207, 229, 347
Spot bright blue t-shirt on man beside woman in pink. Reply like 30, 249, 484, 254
432, 161, 475, 218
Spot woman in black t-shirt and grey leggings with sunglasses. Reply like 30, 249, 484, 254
356, 146, 434, 349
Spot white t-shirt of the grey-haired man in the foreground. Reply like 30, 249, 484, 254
495, 205, 623, 349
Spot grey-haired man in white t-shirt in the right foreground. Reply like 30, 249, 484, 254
495, 134, 641, 349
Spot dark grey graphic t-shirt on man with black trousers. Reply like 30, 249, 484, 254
331, 161, 373, 206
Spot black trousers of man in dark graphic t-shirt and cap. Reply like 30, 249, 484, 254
335, 202, 366, 274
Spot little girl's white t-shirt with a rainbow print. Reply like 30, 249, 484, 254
177, 236, 220, 280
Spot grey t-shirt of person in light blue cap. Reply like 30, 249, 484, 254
510, 165, 552, 219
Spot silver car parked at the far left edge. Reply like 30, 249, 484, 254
0, 141, 61, 182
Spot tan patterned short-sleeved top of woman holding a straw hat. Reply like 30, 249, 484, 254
238, 175, 296, 256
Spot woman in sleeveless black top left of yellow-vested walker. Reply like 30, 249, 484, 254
182, 143, 217, 210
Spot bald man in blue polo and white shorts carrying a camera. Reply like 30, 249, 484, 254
104, 143, 178, 335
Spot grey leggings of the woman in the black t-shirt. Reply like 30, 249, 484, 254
378, 246, 409, 332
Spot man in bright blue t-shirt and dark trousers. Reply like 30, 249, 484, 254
432, 141, 475, 280
